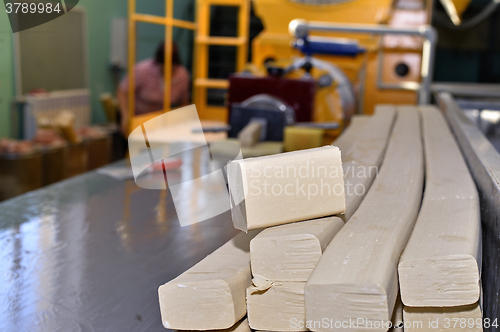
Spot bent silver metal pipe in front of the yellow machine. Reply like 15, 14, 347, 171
289, 19, 437, 104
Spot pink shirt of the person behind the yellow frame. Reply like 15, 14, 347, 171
120, 59, 190, 114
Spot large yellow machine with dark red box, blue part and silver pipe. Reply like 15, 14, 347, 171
213, 0, 436, 147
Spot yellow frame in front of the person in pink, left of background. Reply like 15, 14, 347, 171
128, 0, 197, 133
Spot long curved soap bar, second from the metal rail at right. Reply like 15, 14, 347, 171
305, 107, 423, 331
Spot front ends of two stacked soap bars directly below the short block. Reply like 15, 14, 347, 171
247, 217, 344, 331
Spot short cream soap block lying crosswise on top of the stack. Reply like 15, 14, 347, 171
227, 146, 345, 231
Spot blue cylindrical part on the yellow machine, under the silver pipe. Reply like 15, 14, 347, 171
293, 36, 365, 57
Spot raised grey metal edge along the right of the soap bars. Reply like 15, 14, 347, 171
437, 93, 500, 331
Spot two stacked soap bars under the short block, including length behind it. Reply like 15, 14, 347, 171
247, 106, 396, 331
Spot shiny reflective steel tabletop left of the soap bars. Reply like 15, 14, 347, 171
0, 156, 237, 332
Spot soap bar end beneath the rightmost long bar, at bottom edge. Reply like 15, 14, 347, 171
403, 303, 483, 332
